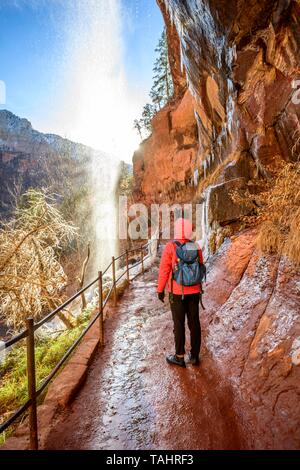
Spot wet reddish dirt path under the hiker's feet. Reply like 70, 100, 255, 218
45, 258, 243, 450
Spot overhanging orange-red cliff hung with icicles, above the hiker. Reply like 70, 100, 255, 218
134, 0, 300, 231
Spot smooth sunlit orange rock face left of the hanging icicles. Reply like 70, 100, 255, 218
133, 91, 198, 202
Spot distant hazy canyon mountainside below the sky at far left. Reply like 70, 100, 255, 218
0, 110, 93, 217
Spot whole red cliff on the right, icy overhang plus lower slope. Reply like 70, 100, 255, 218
134, 0, 300, 449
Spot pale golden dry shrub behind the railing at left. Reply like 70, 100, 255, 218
0, 190, 76, 330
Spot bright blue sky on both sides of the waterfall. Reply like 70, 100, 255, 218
0, 0, 163, 160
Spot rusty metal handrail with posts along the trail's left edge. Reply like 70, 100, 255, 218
0, 239, 158, 449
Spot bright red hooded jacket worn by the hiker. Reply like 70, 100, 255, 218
157, 219, 203, 295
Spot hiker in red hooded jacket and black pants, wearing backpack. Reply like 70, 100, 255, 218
157, 218, 205, 367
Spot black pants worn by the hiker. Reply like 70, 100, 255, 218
170, 294, 201, 358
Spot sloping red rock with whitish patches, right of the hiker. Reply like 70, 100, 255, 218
202, 230, 300, 449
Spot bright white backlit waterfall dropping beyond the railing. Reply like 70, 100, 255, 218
54, 0, 137, 270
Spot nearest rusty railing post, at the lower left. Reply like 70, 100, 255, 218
26, 318, 38, 450
